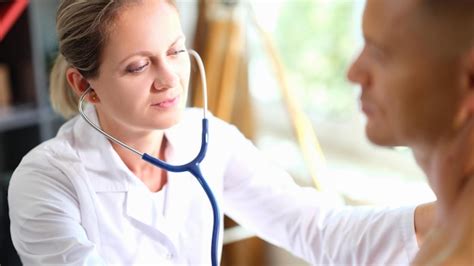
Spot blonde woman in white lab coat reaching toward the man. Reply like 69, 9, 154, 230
8, 0, 427, 265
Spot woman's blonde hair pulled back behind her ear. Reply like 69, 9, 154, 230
50, 0, 177, 118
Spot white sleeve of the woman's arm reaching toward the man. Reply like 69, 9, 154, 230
220, 124, 418, 265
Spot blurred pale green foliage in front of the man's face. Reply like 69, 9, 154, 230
274, 0, 359, 117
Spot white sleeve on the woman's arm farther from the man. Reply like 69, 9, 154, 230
8, 154, 104, 265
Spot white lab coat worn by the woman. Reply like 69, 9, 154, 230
8, 107, 418, 265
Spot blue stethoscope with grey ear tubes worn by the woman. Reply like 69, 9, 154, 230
79, 50, 220, 266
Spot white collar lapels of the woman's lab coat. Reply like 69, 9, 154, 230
73, 105, 202, 188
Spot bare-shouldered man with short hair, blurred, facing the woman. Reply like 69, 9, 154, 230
348, 0, 474, 265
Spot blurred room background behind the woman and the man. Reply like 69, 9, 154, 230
0, 0, 434, 265
